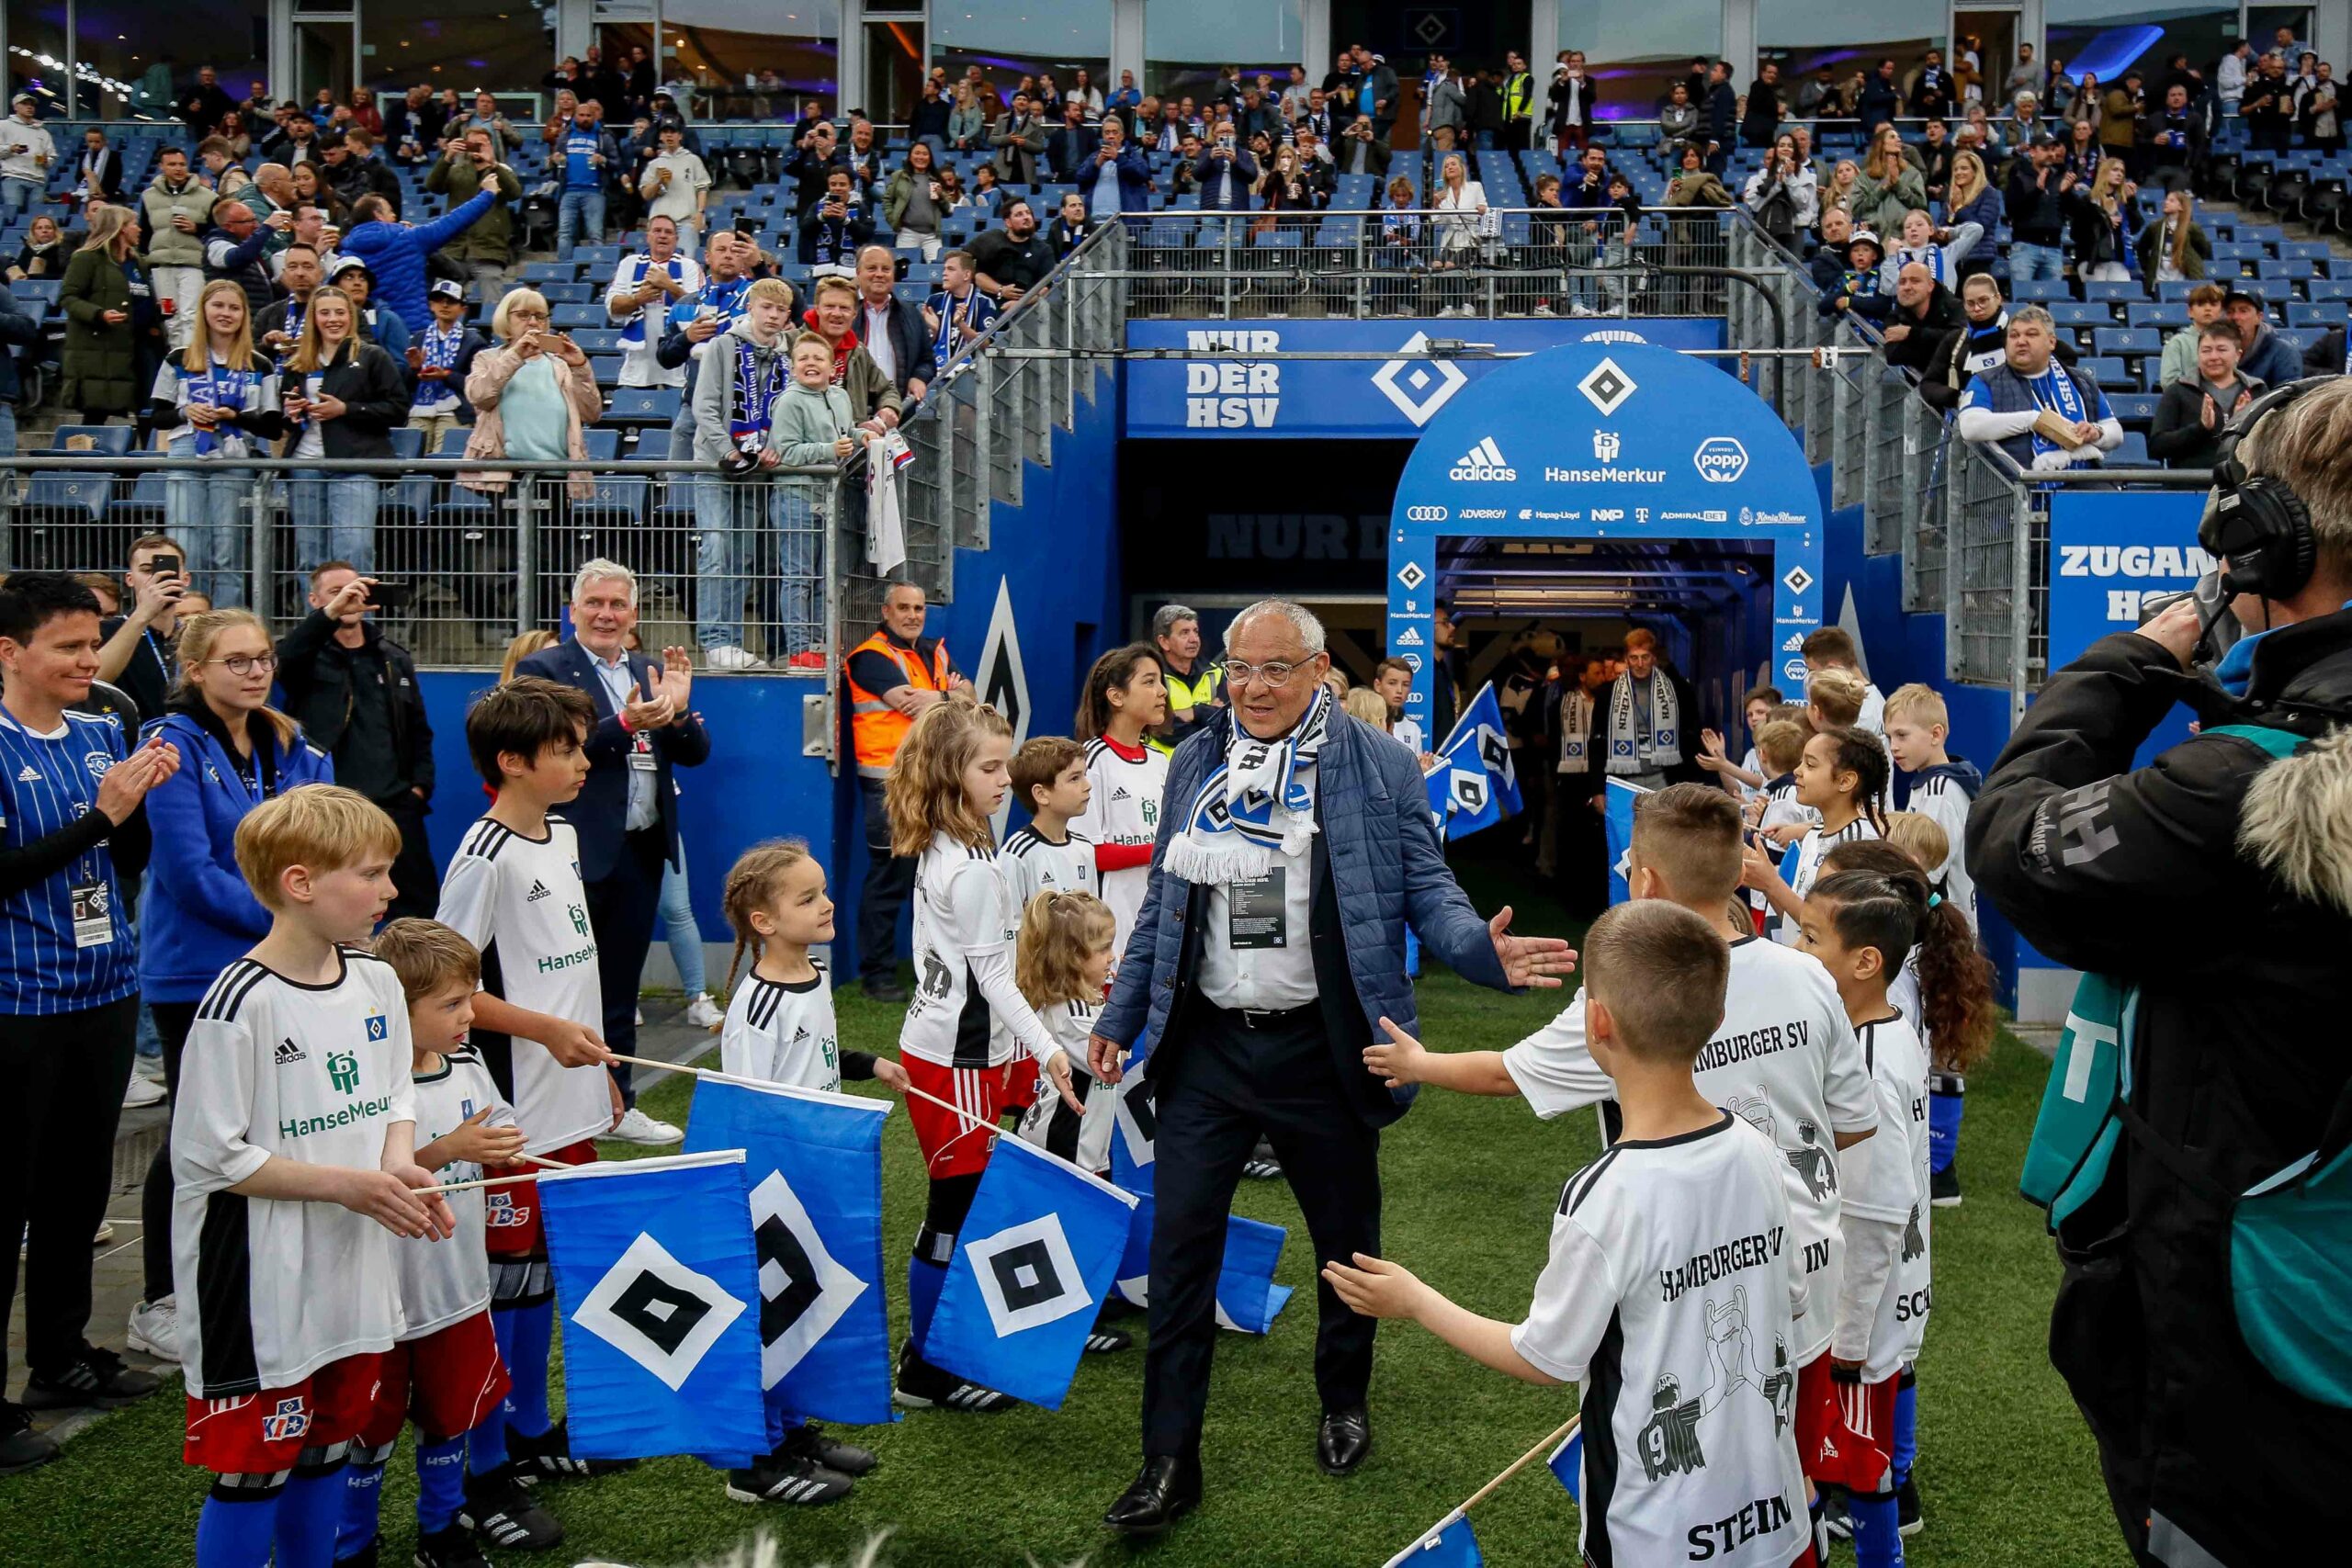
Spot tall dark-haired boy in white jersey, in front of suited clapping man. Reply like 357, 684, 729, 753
437, 674, 621, 1476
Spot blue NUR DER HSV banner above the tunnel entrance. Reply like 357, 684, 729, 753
1125, 317, 1724, 440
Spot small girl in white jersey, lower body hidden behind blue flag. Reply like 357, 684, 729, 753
700, 840, 906, 1505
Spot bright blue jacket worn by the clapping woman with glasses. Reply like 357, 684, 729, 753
139, 712, 334, 1001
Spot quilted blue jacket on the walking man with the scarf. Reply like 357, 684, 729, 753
1093, 707, 1510, 1126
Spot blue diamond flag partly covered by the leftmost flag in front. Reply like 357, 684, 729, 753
687, 1075, 899, 1453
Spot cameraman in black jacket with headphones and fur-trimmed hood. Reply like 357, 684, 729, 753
1969, 378, 2352, 1565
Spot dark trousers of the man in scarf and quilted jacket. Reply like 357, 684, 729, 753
1143, 999, 1381, 1458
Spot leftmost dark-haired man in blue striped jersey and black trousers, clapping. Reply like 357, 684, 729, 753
0, 571, 181, 1474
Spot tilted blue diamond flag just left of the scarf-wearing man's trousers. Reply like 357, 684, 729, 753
922, 1138, 1136, 1411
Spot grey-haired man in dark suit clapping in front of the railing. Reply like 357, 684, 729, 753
515, 559, 710, 1145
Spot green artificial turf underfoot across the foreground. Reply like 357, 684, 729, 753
0, 888, 2126, 1568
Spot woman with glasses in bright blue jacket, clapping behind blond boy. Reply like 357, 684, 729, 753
130, 609, 334, 1361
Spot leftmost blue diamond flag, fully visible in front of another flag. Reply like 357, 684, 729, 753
538, 1149, 769, 1460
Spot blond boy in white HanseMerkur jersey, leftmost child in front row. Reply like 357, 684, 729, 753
172, 785, 452, 1568
